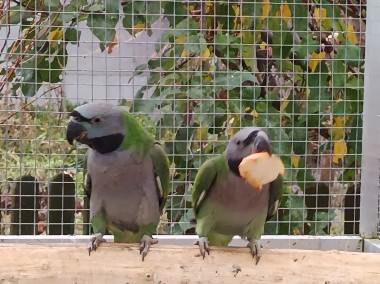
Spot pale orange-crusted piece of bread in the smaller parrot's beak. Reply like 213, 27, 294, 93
239, 152, 285, 190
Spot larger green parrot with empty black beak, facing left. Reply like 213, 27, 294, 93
66, 103, 169, 261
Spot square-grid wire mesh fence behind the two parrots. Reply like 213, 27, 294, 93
0, 0, 372, 241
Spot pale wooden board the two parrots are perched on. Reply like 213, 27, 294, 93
0, 244, 380, 284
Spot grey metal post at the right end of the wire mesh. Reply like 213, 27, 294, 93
360, 0, 380, 238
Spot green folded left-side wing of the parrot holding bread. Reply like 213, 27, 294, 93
192, 157, 220, 215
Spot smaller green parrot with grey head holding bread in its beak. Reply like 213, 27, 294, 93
192, 127, 283, 264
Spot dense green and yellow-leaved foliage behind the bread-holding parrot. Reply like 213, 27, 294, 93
126, 0, 364, 234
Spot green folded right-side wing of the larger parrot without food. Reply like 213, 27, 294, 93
150, 142, 170, 212
